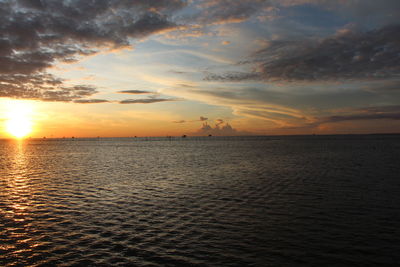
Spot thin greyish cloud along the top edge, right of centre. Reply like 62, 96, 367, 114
186, 0, 400, 28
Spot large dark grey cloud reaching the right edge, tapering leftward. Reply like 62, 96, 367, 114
205, 25, 400, 82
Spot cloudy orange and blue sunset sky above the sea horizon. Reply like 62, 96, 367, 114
0, 0, 400, 138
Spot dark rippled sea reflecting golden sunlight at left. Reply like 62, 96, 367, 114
0, 135, 400, 266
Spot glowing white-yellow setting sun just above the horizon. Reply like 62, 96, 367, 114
6, 101, 33, 138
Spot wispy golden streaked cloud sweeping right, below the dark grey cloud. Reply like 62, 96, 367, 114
173, 78, 400, 133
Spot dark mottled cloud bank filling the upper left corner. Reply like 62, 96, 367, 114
0, 0, 186, 101
